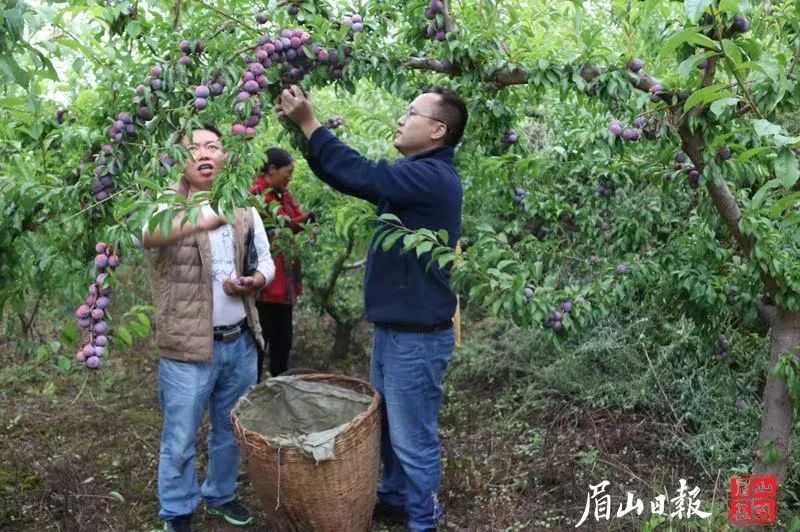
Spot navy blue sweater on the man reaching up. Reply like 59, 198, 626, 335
308, 127, 463, 326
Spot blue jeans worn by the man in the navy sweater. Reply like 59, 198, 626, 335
370, 326, 455, 530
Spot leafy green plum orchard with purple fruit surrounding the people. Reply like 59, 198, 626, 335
0, 0, 800, 524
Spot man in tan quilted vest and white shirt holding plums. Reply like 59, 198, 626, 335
143, 126, 275, 532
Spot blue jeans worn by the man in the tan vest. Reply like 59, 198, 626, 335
158, 330, 258, 520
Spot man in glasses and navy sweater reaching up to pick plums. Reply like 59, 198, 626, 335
275, 86, 467, 531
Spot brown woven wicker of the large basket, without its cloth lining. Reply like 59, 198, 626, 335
231, 373, 381, 532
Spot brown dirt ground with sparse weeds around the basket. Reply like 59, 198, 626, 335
0, 314, 725, 532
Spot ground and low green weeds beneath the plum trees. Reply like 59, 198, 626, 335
0, 264, 800, 531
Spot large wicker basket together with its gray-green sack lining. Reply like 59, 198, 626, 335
231, 374, 381, 532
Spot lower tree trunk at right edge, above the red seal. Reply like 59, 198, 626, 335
755, 308, 800, 484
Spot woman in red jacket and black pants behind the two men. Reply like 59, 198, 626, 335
250, 148, 312, 382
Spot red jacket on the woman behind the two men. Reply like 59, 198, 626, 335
250, 176, 309, 305
